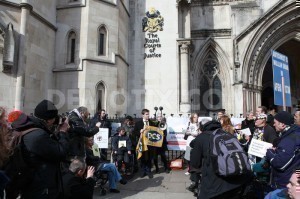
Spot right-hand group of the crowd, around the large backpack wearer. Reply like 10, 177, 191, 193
187, 106, 300, 199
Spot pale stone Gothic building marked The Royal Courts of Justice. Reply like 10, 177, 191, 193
0, 0, 300, 116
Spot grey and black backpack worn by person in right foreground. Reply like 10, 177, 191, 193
209, 129, 251, 177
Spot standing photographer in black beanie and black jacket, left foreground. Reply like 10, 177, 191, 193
12, 100, 69, 199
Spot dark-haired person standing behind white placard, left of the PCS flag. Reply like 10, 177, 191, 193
91, 109, 111, 160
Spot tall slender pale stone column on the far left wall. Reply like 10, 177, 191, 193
15, 0, 32, 110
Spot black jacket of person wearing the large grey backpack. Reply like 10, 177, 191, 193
190, 121, 249, 199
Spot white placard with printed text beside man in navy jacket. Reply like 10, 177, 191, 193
248, 139, 273, 158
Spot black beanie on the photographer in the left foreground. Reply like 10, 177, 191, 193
34, 100, 58, 120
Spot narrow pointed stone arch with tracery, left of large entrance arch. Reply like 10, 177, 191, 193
190, 38, 233, 115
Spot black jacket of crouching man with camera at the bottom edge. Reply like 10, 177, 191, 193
63, 171, 96, 199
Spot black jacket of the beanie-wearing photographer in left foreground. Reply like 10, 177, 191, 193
22, 117, 69, 199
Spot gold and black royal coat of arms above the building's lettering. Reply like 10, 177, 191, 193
142, 8, 164, 32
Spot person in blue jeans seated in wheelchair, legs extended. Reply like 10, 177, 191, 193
86, 137, 127, 194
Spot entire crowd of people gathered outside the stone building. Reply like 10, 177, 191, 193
0, 100, 300, 199
